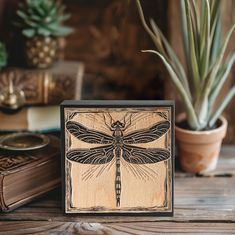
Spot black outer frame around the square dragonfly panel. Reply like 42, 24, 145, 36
60, 100, 175, 216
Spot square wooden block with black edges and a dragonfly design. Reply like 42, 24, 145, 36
61, 101, 174, 216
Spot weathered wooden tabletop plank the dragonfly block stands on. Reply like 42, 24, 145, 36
0, 177, 235, 223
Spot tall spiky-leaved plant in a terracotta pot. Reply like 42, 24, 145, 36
136, 0, 235, 173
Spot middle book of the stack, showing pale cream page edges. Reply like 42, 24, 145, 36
0, 105, 60, 132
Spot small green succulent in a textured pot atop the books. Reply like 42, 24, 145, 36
15, 0, 72, 68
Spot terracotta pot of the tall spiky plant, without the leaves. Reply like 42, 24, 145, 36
175, 115, 227, 173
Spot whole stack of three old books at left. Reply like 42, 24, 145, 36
0, 61, 84, 212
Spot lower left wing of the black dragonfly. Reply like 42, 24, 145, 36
67, 145, 114, 165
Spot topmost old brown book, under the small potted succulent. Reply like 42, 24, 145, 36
0, 61, 84, 105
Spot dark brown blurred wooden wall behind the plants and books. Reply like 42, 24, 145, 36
0, 0, 235, 143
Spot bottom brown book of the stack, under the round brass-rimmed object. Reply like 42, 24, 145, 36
0, 136, 60, 212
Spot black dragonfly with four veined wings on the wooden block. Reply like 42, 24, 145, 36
66, 116, 170, 207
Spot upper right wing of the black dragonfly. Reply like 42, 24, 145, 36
123, 121, 170, 144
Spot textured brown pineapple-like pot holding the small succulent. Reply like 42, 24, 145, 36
25, 36, 58, 69
